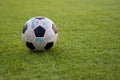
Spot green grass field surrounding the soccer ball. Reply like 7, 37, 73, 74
0, 0, 120, 80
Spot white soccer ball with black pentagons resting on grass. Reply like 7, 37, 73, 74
22, 16, 58, 51
